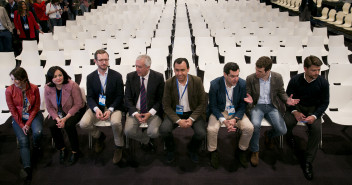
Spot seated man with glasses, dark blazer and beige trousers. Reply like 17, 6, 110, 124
79, 50, 124, 164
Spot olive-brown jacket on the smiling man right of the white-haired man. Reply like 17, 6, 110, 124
163, 74, 206, 123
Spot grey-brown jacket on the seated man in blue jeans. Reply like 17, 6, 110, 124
246, 71, 288, 110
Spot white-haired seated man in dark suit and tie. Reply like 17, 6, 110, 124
125, 55, 165, 149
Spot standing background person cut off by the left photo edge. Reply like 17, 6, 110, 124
0, 6, 13, 52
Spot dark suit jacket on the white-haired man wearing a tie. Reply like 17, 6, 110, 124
125, 70, 165, 118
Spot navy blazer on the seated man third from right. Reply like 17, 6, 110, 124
209, 76, 247, 119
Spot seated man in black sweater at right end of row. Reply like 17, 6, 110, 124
284, 56, 329, 180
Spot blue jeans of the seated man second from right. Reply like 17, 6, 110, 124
250, 104, 287, 152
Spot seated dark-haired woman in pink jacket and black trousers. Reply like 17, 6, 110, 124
44, 66, 86, 165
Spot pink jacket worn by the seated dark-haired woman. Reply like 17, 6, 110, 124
44, 80, 84, 119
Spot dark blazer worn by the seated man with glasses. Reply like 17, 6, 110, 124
87, 68, 124, 112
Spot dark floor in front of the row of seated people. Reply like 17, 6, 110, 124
0, 112, 352, 185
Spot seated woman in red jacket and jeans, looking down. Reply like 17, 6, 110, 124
5, 67, 43, 184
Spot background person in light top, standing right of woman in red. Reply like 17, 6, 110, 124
46, 0, 63, 32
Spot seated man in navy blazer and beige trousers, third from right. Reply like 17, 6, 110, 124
207, 62, 253, 168
